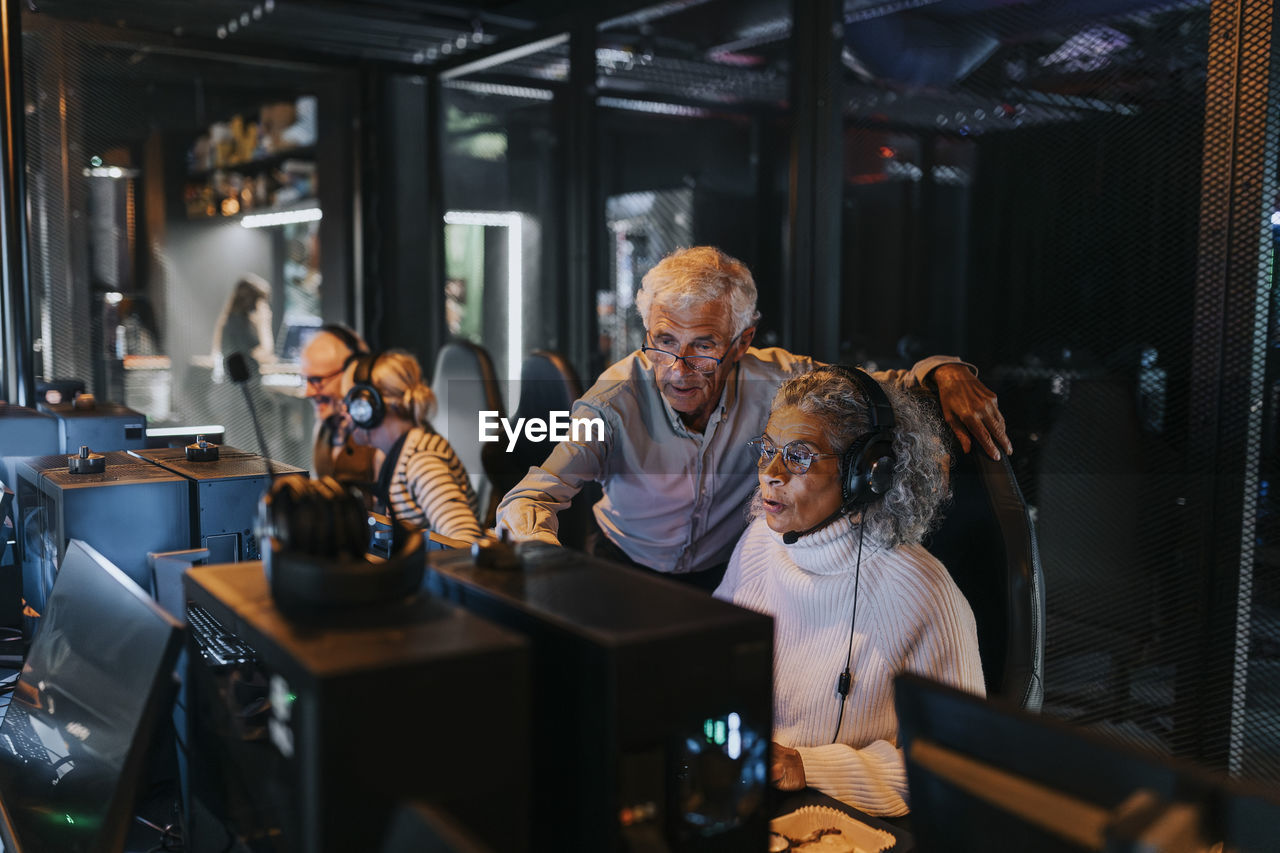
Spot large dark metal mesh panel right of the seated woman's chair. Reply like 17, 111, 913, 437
842, 1, 1280, 780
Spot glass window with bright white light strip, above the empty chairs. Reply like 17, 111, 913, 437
440, 38, 568, 389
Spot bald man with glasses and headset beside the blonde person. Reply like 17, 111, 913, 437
300, 323, 378, 496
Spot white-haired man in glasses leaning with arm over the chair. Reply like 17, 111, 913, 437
497, 246, 1012, 590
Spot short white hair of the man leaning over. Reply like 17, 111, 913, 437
636, 246, 760, 337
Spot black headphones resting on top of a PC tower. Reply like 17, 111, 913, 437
259, 475, 426, 620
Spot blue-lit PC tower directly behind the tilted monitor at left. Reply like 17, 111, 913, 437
17, 452, 191, 613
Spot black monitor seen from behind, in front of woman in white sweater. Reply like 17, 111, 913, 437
895, 675, 1280, 853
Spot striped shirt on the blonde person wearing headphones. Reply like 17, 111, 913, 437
388, 427, 480, 542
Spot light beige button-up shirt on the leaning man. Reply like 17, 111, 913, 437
497, 347, 957, 574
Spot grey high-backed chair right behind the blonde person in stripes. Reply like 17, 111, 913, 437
431, 339, 504, 528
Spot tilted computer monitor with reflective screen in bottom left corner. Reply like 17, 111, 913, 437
0, 539, 182, 853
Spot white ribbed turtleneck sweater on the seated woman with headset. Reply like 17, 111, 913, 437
716, 519, 986, 816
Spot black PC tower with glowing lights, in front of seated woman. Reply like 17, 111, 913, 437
425, 543, 773, 853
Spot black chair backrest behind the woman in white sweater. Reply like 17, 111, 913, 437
925, 440, 1044, 711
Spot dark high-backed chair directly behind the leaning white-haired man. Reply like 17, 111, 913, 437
484, 350, 600, 549
